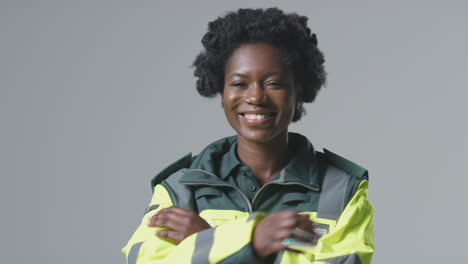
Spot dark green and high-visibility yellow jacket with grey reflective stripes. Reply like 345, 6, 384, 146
122, 133, 374, 264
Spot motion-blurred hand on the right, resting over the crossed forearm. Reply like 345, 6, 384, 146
253, 210, 318, 257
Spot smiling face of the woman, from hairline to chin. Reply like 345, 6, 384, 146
223, 43, 299, 142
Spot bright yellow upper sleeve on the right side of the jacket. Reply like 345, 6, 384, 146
313, 180, 374, 264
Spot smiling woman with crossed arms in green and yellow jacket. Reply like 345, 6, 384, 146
122, 8, 373, 263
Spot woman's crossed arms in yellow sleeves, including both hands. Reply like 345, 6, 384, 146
122, 182, 373, 264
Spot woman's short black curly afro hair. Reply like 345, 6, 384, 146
192, 8, 326, 122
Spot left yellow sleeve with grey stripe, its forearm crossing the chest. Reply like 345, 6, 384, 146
122, 185, 263, 264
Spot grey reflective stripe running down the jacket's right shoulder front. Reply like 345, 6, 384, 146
317, 166, 351, 220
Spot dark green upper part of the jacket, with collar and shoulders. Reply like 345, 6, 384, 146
148, 133, 367, 216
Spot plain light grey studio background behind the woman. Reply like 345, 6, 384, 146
0, 0, 468, 263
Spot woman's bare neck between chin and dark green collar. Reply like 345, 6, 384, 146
237, 132, 291, 186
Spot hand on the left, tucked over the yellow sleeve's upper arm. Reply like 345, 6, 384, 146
147, 206, 211, 244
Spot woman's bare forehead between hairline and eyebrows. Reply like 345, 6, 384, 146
225, 43, 285, 75
